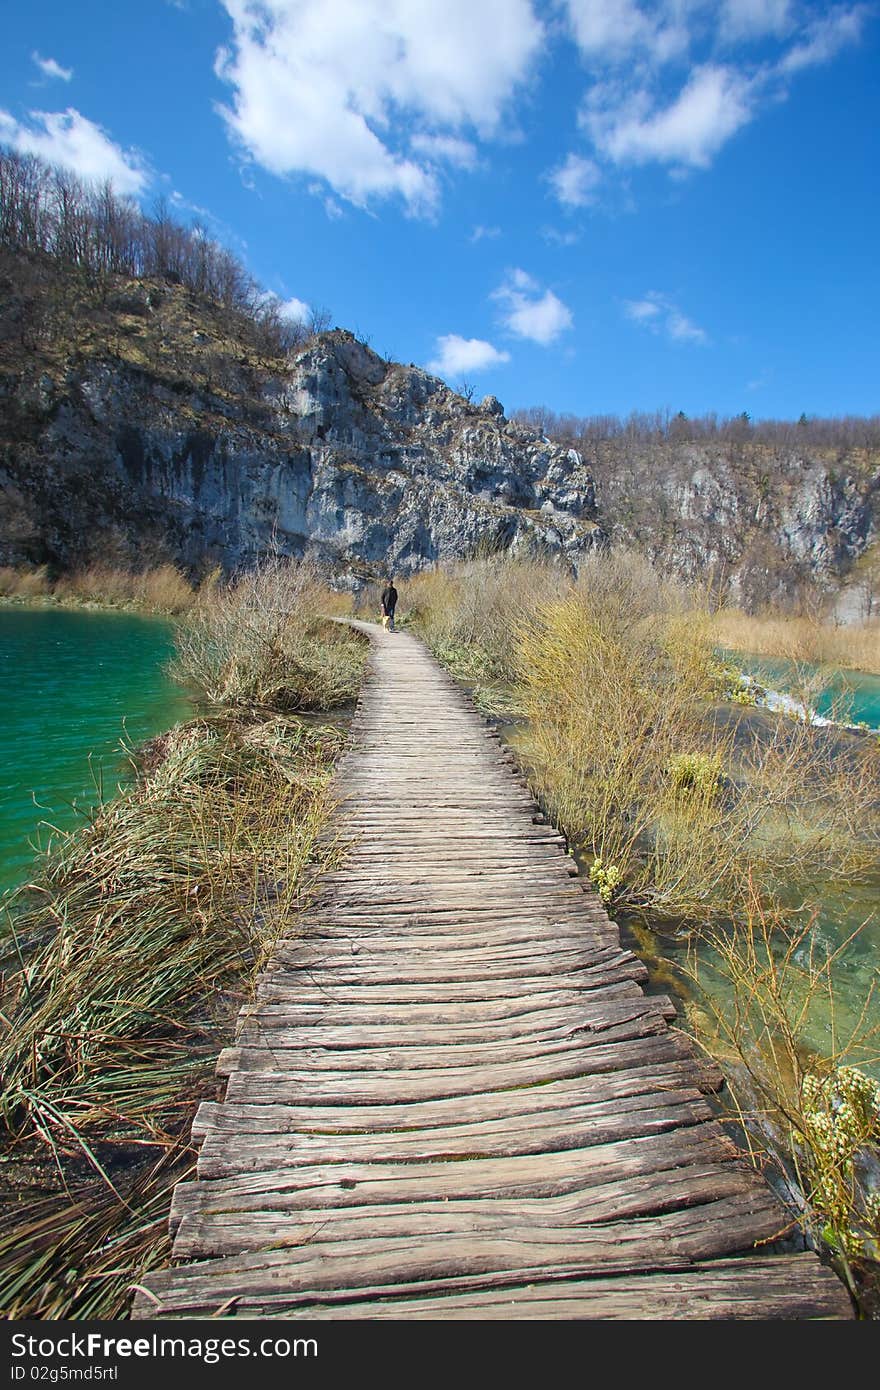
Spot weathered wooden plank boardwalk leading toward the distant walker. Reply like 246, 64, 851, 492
133, 624, 851, 1319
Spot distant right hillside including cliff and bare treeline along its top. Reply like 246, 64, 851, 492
517, 407, 880, 619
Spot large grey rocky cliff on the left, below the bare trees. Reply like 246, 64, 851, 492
0, 265, 602, 577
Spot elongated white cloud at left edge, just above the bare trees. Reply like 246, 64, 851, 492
0, 107, 149, 196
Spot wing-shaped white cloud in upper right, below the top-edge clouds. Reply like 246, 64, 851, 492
584, 64, 753, 168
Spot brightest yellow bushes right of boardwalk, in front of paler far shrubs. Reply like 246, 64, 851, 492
519, 591, 880, 926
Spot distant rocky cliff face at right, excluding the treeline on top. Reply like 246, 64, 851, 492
584, 428, 880, 617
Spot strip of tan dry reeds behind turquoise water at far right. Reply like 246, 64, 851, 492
712, 607, 880, 674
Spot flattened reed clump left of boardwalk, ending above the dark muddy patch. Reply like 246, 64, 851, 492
0, 716, 339, 1147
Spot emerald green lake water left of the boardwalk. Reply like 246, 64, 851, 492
0, 607, 192, 888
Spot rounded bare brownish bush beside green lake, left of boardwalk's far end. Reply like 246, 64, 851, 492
171, 557, 367, 710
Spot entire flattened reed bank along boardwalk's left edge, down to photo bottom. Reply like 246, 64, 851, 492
0, 714, 343, 1318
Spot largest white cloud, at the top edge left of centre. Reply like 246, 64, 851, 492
217, 0, 544, 214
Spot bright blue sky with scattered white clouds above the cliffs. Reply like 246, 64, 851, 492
0, 0, 880, 418
